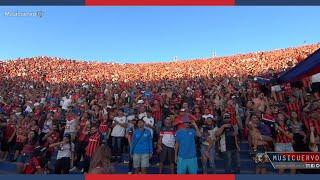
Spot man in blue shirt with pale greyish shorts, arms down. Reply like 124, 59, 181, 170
131, 119, 153, 174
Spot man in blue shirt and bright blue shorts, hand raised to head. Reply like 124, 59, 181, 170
175, 121, 201, 174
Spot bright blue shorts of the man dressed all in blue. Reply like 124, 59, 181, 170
177, 157, 198, 174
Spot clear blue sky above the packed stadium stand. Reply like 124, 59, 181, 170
0, 7, 320, 63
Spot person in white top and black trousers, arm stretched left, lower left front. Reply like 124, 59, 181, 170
49, 134, 74, 174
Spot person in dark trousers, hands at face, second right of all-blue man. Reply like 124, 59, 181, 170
216, 113, 240, 174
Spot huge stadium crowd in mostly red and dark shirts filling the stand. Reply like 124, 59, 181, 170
0, 44, 320, 174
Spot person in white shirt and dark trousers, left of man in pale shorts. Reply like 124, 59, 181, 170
111, 110, 127, 161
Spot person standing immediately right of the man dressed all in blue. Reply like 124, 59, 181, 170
201, 117, 218, 174
